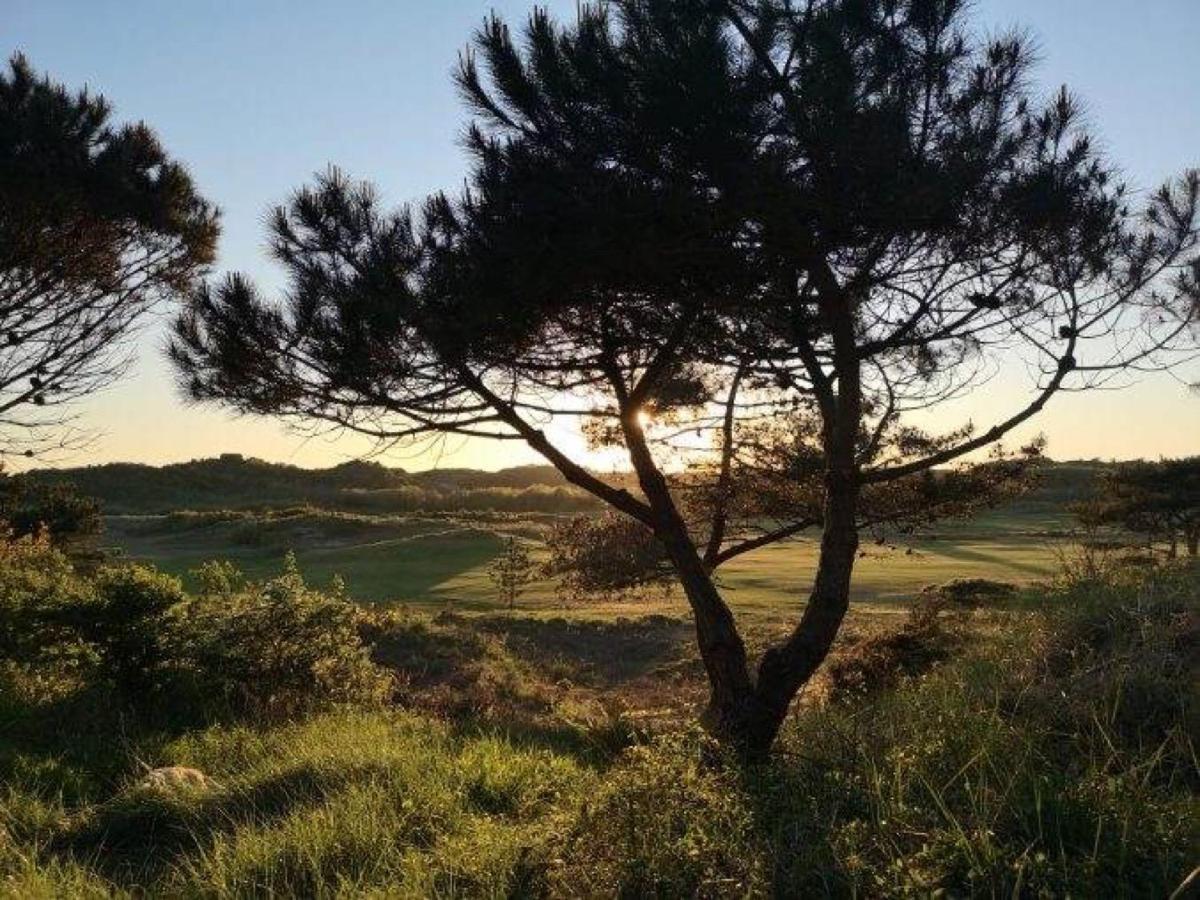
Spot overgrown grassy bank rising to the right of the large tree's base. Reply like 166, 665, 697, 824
551, 570, 1200, 898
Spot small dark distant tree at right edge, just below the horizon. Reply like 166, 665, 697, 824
1075, 456, 1200, 558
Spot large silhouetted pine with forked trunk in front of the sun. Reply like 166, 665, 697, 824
172, 0, 1200, 754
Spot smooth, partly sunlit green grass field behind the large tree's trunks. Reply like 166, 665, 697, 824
104, 509, 1064, 618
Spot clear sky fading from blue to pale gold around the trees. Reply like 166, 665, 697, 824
9, 0, 1200, 469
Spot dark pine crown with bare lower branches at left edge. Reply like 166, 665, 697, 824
0, 55, 217, 456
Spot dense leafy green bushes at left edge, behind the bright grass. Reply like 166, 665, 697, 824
0, 538, 391, 720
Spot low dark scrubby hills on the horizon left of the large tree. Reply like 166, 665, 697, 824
20, 454, 596, 515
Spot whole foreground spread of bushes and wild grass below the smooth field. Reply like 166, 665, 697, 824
0, 536, 1200, 896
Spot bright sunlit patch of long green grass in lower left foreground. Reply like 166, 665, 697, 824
0, 712, 595, 898
